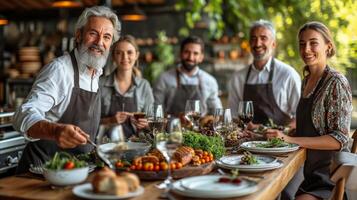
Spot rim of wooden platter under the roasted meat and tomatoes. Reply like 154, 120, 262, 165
131, 162, 215, 180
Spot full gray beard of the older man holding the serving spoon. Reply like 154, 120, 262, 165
78, 44, 109, 70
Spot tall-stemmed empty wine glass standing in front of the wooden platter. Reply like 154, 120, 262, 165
155, 118, 183, 190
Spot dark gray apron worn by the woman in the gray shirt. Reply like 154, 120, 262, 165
107, 81, 137, 138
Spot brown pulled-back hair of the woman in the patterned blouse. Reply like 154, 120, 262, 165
298, 21, 336, 76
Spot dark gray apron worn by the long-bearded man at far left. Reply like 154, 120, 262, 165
16, 51, 100, 174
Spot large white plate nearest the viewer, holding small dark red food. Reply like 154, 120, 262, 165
172, 175, 258, 199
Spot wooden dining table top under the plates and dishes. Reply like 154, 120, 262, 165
0, 148, 306, 200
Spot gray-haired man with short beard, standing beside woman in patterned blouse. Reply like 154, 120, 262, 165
228, 20, 301, 127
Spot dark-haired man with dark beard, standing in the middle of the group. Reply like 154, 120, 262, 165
153, 36, 222, 116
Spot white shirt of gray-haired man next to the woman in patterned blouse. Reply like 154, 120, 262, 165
228, 59, 301, 118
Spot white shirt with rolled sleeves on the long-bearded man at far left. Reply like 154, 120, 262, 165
13, 50, 102, 139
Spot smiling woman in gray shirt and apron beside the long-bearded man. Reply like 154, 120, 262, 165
100, 35, 154, 138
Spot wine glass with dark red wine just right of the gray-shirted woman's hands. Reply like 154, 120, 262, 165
146, 104, 166, 135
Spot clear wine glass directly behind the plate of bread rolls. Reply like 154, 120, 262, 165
96, 124, 128, 170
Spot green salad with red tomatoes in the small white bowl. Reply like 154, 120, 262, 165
45, 152, 87, 170
